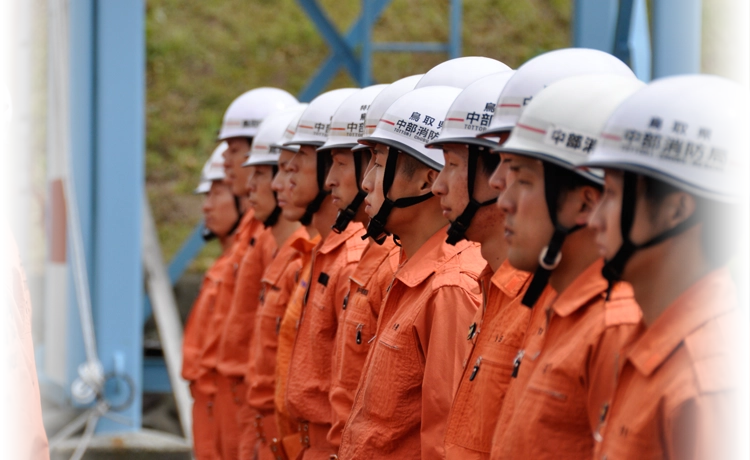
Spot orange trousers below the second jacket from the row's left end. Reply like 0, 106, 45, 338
214, 374, 247, 460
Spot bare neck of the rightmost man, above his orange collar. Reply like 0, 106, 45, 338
627, 235, 713, 326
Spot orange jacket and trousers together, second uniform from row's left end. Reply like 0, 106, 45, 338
199, 210, 261, 459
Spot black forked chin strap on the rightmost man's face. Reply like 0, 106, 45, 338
602, 172, 703, 299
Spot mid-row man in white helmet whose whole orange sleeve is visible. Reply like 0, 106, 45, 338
338, 84, 483, 459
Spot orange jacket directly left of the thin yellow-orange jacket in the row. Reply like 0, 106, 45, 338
245, 227, 309, 414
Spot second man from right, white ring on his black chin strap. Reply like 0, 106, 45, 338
491, 68, 643, 459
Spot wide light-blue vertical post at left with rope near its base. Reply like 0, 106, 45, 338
92, 0, 146, 433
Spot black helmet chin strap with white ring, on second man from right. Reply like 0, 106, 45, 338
521, 162, 584, 308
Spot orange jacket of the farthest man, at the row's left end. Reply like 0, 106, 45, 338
182, 254, 229, 382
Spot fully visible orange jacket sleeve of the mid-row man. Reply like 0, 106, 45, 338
414, 286, 481, 459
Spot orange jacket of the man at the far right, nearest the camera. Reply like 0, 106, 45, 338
595, 267, 747, 459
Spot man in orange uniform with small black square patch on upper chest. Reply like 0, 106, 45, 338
285, 88, 366, 460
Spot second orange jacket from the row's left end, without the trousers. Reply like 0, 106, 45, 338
200, 210, 261, 372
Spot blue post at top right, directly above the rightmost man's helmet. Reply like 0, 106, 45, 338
651, 0, 702, 78
